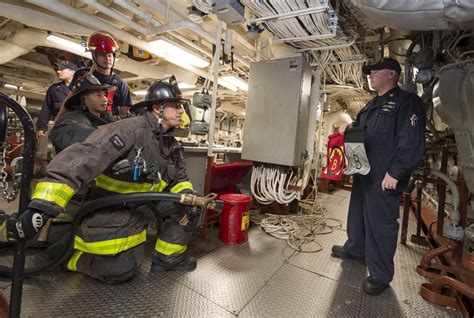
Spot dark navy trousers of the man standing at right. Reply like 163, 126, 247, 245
344, 173, 400, 284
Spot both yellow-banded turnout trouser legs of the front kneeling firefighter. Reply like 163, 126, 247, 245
53, 201, 197, 283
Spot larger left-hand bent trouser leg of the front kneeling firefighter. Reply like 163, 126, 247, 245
67, 209, 147, 283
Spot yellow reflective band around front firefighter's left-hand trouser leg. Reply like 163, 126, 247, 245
74, 230, 146, 255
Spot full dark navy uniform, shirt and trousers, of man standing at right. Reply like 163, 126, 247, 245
344, 86, 426, 284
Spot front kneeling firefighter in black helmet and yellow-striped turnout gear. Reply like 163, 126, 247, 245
0, 82, 196, 283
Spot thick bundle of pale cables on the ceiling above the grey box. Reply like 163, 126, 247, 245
242, 0, 365, 88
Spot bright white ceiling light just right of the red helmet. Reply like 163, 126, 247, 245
149, 38, 209, 68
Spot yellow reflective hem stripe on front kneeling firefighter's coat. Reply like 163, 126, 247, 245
95, 174, 168, 193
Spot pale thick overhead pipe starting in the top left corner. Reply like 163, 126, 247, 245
0, 2, 94, 35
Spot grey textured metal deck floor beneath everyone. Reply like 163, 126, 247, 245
0, 191, 460, 317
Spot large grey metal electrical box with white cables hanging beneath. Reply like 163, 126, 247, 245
242, 56, 319, 167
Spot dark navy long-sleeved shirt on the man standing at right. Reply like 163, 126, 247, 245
353, 86, 426, 181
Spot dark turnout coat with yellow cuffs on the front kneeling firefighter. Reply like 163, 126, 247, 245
29, 112, 192, 216
